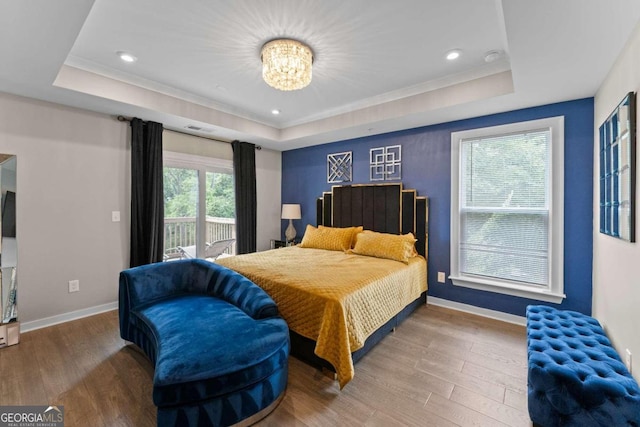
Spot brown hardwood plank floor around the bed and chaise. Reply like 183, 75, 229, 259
0, 305, 531, 427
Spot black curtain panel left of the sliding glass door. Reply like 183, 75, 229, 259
129, 118, 164, 267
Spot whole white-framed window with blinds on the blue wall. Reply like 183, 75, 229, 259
450, 117, 564, 303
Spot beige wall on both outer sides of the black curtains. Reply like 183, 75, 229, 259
0, 93, 281, 327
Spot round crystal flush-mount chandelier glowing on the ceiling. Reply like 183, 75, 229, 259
260, 39, 313, 90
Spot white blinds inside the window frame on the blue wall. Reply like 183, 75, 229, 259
459, 129, 551, 286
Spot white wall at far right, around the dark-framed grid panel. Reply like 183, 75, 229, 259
593, 20, 640, 379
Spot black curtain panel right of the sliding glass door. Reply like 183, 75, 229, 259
231, 141, 258, 254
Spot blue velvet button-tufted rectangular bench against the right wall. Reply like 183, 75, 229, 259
527, 305, 640, 427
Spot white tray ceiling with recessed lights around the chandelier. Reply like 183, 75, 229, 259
0, 0, 640, 150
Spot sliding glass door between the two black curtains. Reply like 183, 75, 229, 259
163, 152, 236, 260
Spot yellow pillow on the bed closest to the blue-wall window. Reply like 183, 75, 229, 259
351, 230, 417, 264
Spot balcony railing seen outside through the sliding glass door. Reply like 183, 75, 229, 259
164, 216, 236, 258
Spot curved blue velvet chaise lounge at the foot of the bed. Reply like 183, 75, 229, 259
119, 259, 289, 427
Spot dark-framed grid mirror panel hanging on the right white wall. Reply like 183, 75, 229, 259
599, 92, 636, 242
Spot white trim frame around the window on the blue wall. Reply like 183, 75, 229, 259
449, 116, 566, 303
